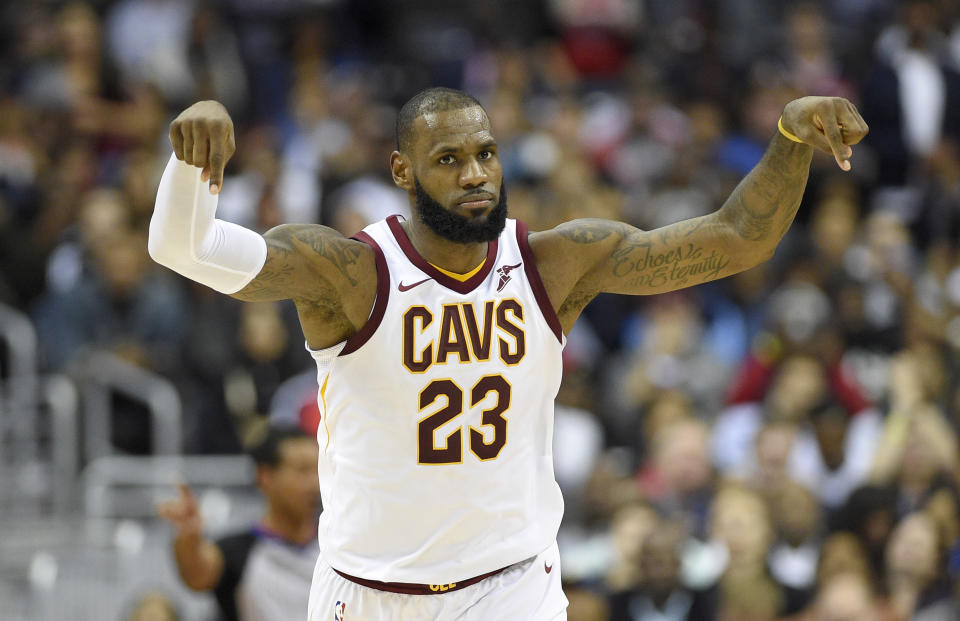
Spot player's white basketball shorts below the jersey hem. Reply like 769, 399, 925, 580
308, 543, 567, 621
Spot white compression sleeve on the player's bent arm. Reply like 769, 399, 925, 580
147, 155, 267, 294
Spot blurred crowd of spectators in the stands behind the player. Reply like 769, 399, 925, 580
0, 0, 960, 621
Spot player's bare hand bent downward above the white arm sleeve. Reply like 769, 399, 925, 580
170, 101, 237, 194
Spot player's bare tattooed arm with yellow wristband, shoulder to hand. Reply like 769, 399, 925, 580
530, 98, 867, 330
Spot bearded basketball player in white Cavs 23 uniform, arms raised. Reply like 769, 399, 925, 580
149, 88, 867, 621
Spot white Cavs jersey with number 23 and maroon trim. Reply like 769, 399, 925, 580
311, 216, 564, 584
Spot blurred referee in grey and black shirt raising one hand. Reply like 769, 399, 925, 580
158, 429, 320, 621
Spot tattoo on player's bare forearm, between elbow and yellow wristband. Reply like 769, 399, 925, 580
720, 136, 813, 244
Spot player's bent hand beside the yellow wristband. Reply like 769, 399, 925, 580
783, 97, 870, 170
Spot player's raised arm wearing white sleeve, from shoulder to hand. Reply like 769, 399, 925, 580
148, 101, 377, 348
